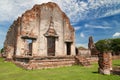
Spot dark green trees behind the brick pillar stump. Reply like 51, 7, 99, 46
95, 38, 120, 55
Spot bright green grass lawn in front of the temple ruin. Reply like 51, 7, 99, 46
0, 58, 120, 80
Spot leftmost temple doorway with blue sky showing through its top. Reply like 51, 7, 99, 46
25, 39, 33, 56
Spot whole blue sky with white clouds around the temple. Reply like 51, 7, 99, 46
0, 0, 120, 48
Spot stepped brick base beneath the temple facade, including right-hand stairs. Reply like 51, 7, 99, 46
14, 56, 90, 70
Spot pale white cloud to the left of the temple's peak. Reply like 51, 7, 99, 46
0, 0, 51, 22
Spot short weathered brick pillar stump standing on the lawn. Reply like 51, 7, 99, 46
98, 52, 112, 74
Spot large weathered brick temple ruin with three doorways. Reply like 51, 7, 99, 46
4, 2, 79, 68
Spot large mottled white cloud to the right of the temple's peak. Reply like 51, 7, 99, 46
54, 0, 120, 22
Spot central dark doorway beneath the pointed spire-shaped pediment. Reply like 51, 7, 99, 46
47, 37, 55, 56
